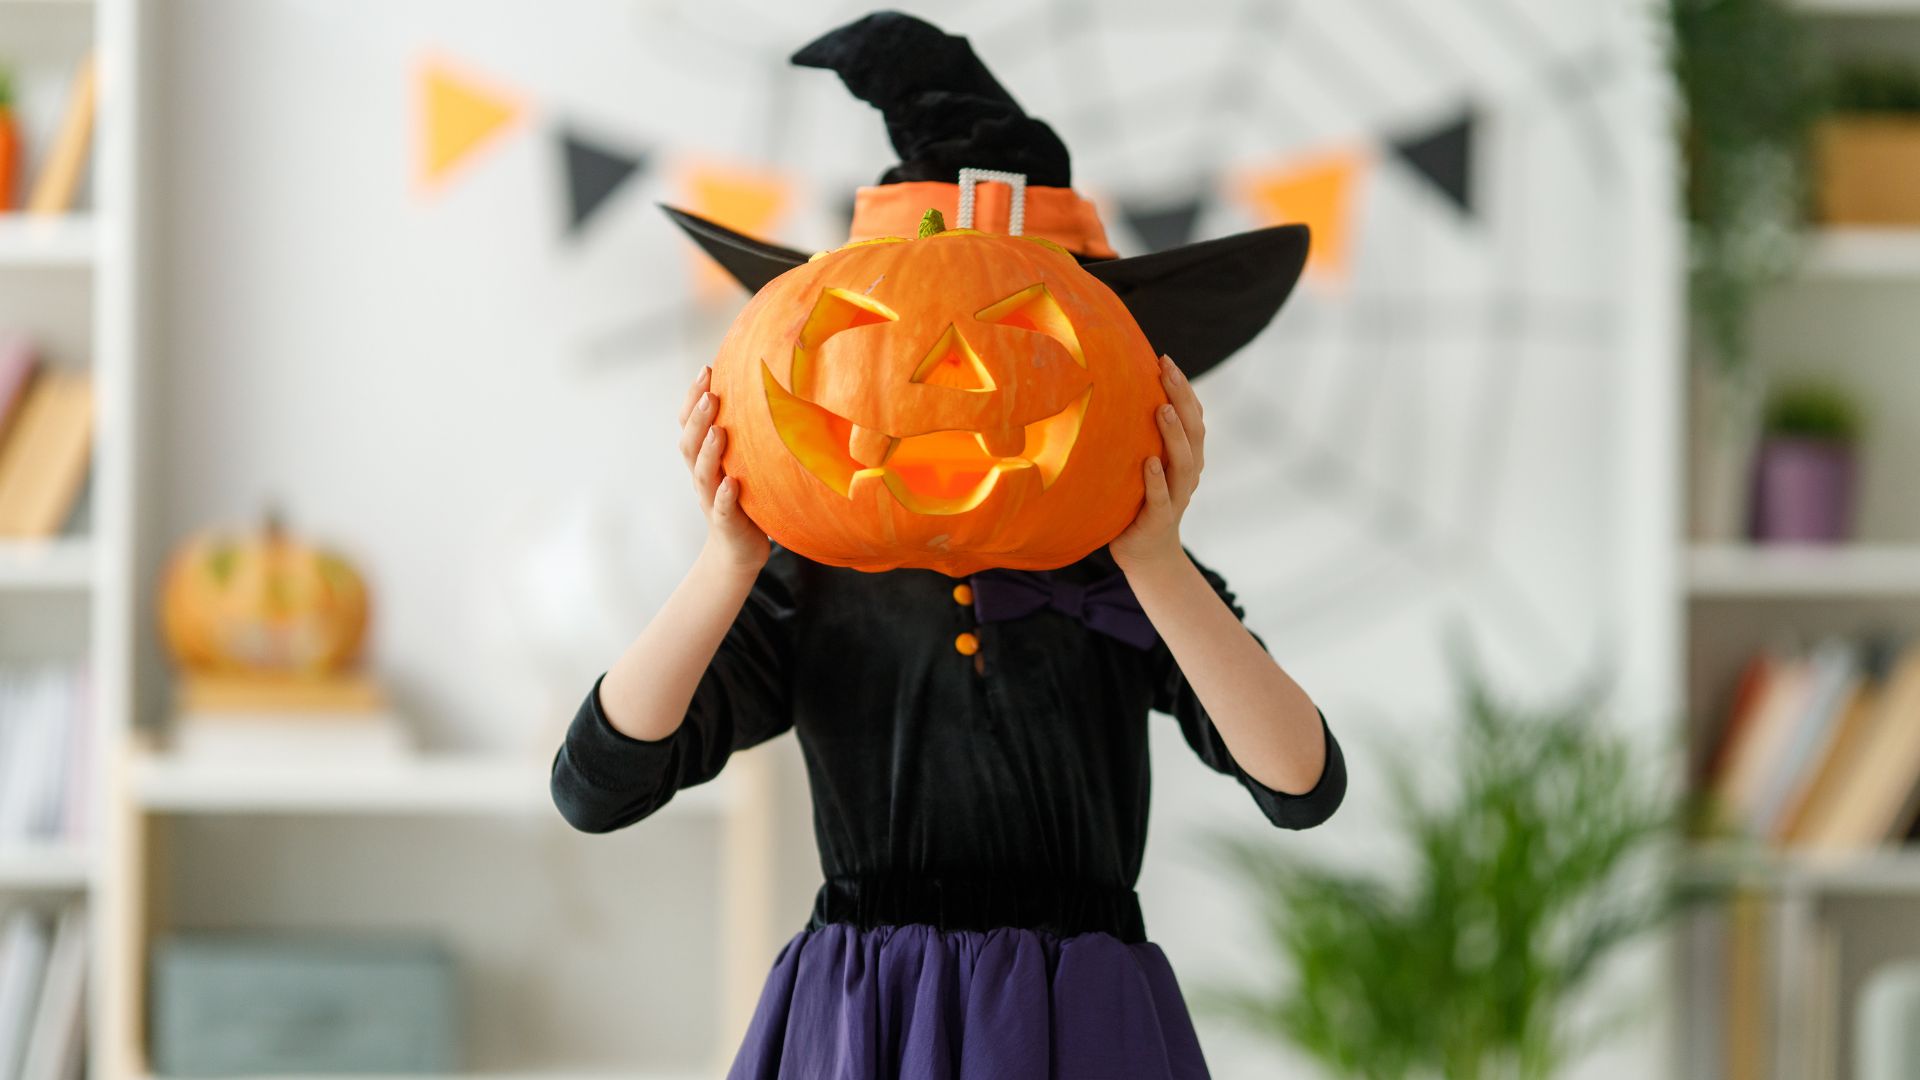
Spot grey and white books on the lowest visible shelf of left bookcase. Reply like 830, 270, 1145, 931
0, 905, 86, 1080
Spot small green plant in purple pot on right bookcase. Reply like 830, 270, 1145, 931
1753, 382, 1860, 544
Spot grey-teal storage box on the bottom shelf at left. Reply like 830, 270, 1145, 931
150, 934, 459, 1076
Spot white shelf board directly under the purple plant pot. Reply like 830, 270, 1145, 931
1686, 544, 1920, 598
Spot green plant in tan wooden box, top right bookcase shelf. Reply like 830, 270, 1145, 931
1814, 60, 1920, 225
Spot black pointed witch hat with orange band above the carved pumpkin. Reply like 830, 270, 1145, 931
662, 12, 1308, 377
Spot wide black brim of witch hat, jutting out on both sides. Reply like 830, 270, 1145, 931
660, 206, 1311, 379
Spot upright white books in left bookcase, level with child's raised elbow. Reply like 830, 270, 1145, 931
0, 663, 92, 849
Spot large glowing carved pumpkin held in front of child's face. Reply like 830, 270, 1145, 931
712, 215, 1165, 577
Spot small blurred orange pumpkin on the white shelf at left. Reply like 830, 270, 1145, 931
159, 513, 367, 675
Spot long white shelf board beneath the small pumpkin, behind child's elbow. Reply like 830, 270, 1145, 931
132, 753, 732, 821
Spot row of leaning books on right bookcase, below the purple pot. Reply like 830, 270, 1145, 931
1703, 640, 1920, 851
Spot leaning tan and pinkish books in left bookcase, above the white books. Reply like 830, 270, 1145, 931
0, 334, 94, 538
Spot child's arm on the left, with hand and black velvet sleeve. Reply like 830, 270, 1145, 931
553, 369, 791, 832
